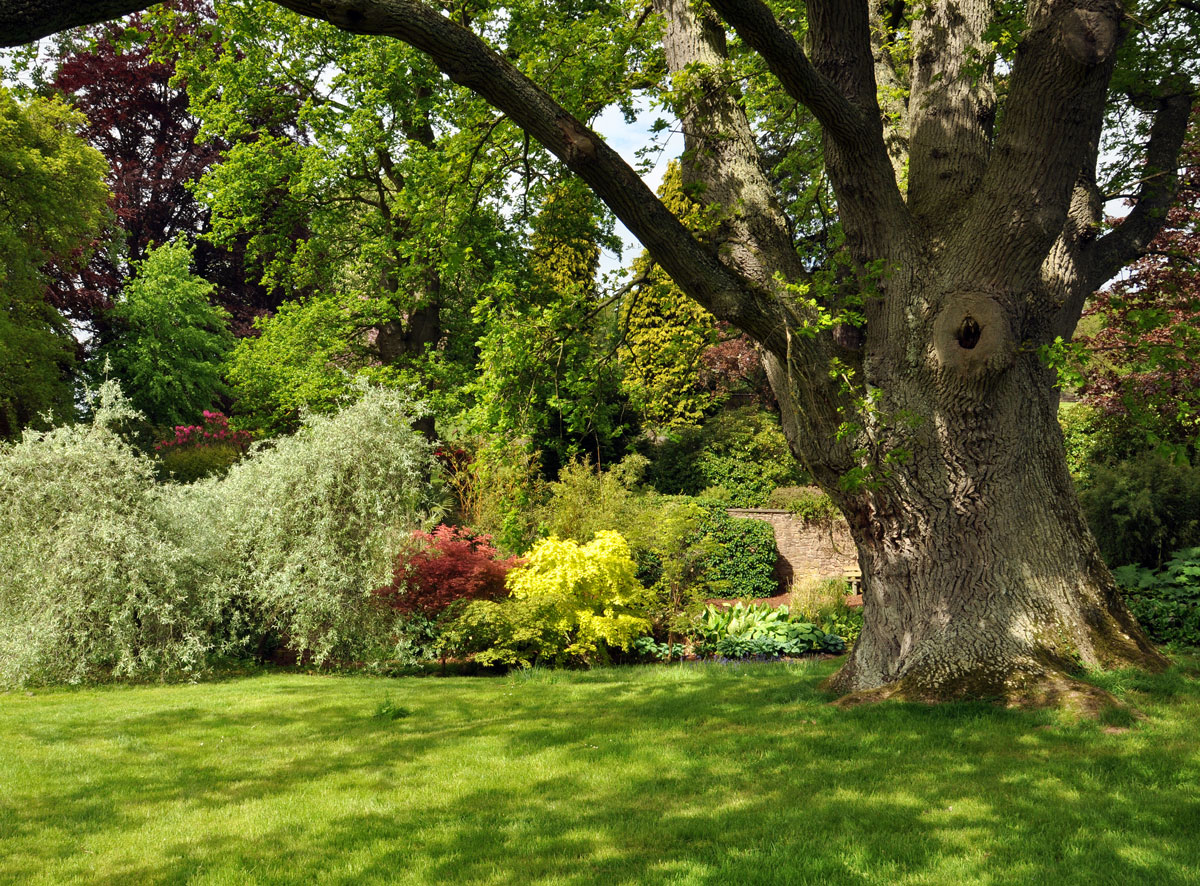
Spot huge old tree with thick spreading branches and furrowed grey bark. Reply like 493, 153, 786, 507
0, 0, 1200, 699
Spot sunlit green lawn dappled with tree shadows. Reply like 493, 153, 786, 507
0, 659, 1200, 886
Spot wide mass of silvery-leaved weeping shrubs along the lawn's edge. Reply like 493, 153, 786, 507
0, 384, 443, 686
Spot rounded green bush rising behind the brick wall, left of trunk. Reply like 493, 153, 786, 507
647, 406, 804, 508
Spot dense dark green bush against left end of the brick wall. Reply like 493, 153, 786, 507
696, 499, 779, 598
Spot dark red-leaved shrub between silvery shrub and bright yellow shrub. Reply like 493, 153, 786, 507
374, 526, 521, 618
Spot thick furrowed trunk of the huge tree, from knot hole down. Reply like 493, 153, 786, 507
830, 316, 1165, 702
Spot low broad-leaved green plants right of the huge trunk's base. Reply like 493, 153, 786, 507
1112, 547, 1200, 647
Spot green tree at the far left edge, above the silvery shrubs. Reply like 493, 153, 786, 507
0, 86, 108, 439
